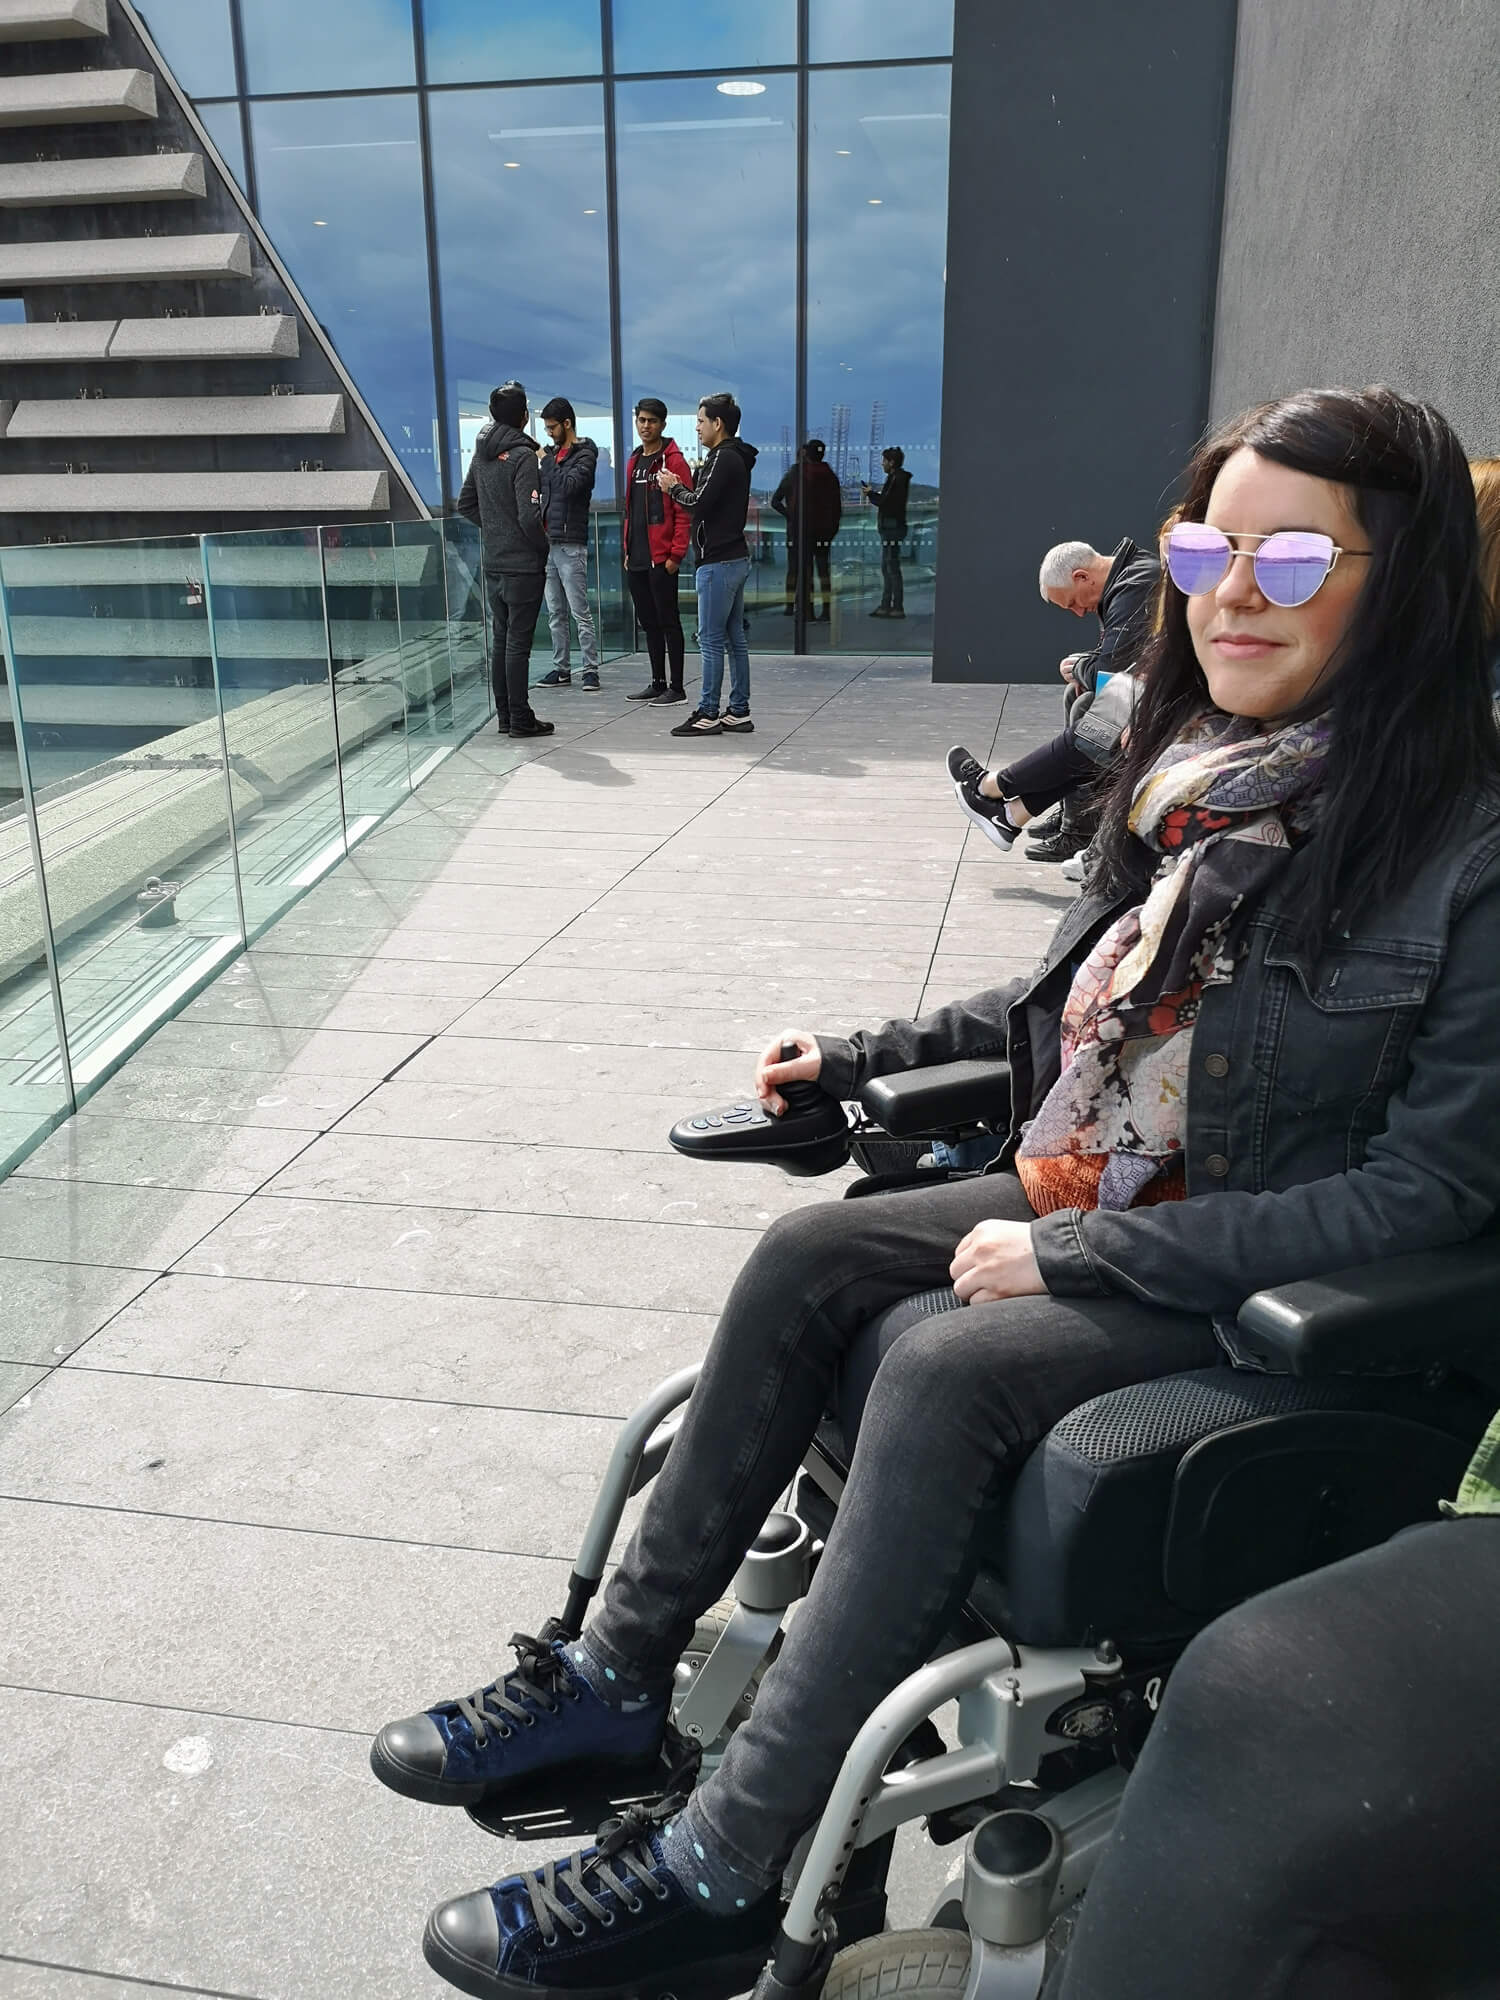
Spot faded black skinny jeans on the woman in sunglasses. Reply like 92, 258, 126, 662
590, 1174, 1218, 1888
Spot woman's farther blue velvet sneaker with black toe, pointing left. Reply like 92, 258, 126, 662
370, 1632, 670, 1806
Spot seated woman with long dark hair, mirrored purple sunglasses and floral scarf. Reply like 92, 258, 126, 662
372, 388, 1500, 1996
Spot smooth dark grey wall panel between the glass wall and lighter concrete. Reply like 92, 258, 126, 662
934, 0, 1240, 682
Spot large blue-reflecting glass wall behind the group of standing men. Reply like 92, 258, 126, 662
156, 0, 952, 652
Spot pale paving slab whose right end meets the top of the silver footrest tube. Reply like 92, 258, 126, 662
73, 1272, 720, 1416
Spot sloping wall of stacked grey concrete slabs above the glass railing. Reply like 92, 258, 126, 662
0, 0, 426, 546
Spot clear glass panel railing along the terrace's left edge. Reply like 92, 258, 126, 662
0, 514, 632, 1176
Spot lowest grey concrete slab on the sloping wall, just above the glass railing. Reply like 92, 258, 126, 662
0, 472, 390, 516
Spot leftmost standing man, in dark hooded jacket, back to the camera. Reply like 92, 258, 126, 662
458, 382, 552, 736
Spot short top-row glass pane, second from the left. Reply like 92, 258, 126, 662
240, 0, 416, 94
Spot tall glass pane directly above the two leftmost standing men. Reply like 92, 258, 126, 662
428, 84, 614, 498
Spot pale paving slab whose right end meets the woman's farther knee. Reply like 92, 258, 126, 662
182, 1188, 754, 1312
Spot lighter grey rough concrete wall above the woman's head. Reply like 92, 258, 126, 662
1212, 0, 1500, 452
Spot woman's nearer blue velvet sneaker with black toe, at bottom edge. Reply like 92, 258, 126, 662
422, 1800, 782, 2000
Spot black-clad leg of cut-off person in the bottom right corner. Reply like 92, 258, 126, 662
1048, 1518, 1500, 2000
